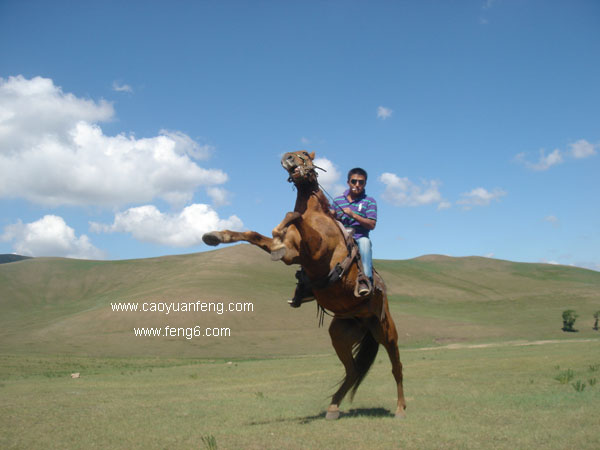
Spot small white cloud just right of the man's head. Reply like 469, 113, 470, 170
379, 172, 448, 209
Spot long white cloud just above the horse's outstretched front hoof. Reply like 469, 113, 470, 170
90, 204, 244, 247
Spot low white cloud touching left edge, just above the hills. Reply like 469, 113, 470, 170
1, 215, 106, 259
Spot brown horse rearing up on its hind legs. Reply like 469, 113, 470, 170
202, 151, 406, 419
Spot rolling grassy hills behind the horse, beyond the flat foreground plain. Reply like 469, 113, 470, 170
0, 245, 600, 358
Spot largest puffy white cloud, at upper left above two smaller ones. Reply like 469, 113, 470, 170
0, 76, 227, 206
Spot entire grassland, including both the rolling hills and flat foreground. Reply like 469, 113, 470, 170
0, 245, 600, 449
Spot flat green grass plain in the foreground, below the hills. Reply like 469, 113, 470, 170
0, 342, 600, 449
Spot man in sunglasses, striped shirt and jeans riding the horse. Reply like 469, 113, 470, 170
288, 167, 377, 308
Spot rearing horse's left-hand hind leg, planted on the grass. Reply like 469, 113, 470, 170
325, 317, 367, 419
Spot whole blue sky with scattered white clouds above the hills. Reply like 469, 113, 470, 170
0, 0, 600, 270
